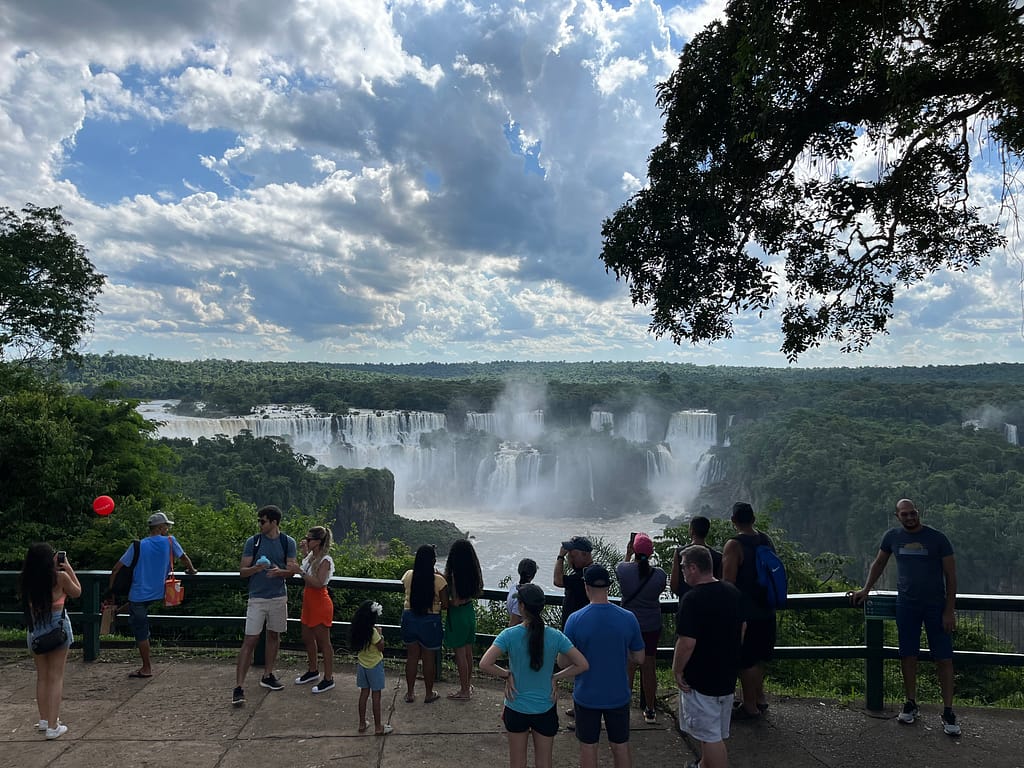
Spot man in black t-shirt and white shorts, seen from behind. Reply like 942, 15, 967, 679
672, 545, 743, 768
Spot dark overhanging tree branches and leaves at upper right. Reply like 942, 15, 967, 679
601, 0, 1024, 359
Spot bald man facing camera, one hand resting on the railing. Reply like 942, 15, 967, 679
850, 499, 961, 736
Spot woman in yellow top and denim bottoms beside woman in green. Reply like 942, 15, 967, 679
401, 544, 447, 703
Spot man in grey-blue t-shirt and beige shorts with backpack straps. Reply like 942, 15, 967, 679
231, 504, 299, 707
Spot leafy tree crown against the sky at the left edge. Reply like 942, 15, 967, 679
0, 205, 105, 360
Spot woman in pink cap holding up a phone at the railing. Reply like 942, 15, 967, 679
615, 534, 668, 723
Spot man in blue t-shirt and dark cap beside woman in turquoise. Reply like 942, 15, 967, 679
565, 563, 644, 768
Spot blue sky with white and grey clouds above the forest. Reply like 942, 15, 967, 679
0, 0, 1024, 367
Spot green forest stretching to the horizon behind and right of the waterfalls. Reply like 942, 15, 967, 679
56, 354, 1024, 593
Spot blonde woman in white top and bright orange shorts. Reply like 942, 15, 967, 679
295, 525, 334, 693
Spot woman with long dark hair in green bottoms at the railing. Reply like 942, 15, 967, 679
444, 539, 483, 701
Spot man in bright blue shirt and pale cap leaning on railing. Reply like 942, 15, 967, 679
111, 512, 196, 677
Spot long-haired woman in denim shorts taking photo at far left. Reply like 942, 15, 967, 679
20, 544, 82, 739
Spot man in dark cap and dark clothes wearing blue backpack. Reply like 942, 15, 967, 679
722, 502, 785, 720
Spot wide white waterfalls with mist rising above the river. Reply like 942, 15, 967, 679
139, 384, 720, 515
